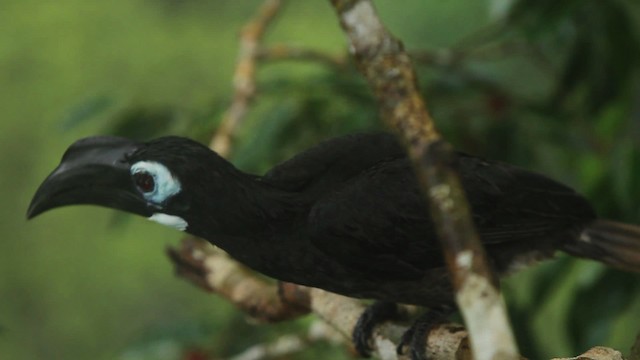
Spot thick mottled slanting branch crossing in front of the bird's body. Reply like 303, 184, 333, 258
331, 0, 517, 359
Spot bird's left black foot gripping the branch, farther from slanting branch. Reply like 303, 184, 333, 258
352, 301, 398, 357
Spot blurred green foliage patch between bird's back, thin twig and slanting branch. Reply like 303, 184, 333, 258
233, 72, 380, 173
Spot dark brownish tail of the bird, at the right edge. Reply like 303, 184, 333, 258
564, 220, 640, 272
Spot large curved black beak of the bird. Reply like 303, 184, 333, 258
27, 136, 152, 219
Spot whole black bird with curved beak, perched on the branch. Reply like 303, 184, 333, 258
27, 133, 640, 357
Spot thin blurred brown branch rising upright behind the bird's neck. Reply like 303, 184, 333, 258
210, 0, 282, 157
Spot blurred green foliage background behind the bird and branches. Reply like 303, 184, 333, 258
0, 0, 640, 360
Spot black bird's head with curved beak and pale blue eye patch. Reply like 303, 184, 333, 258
27, 136, 238, 233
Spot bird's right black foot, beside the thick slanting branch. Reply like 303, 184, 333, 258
397, 306, 454, 360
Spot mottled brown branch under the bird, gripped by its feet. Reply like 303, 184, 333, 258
168, 237, 469, 360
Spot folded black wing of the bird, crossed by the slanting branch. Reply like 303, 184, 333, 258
308, 146, 595, 279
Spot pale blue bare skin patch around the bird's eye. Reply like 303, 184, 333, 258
131, 161, 182, 205
